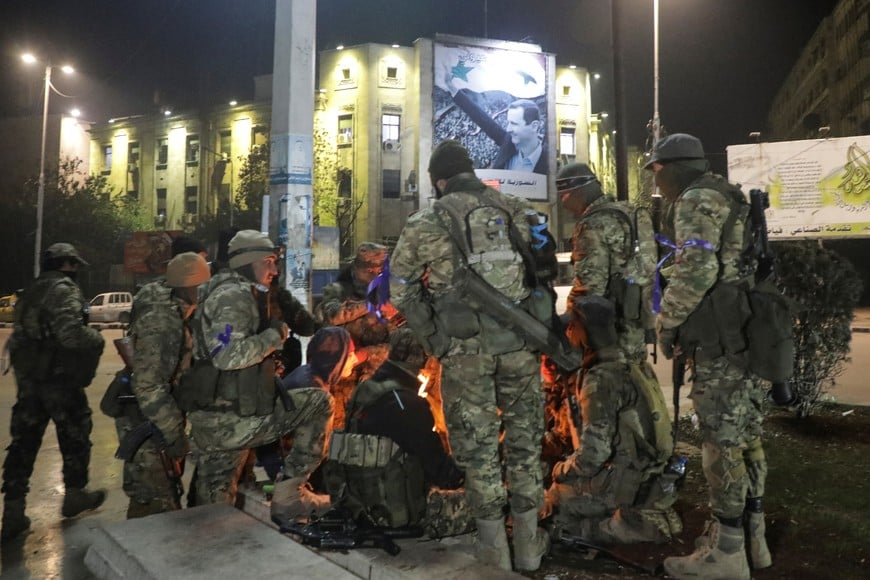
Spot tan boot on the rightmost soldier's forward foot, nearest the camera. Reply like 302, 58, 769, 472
664, 519, 750, 580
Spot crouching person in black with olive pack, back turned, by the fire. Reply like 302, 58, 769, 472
326, 328, 472, 538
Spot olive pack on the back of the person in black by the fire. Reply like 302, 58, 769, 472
324, 378, 426, 528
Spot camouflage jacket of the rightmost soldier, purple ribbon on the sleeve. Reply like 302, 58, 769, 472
659, 176, 745, 328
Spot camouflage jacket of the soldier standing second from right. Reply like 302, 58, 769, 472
568, 196, 656, 359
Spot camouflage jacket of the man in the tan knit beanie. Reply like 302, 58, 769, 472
130, 280, 193, 444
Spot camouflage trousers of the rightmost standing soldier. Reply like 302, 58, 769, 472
690, 357, 767, 518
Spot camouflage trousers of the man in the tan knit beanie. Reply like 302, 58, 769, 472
115, 417, 181, 517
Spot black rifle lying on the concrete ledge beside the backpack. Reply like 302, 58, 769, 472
272, 510, 423, 556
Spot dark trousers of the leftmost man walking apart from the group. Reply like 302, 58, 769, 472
3, 380, 93, 499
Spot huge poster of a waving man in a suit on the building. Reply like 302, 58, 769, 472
432, 43, 550, 201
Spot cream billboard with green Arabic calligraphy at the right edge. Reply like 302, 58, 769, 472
727, 135, 870, 239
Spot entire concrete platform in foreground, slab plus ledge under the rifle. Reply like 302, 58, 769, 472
85, 488, 523, 580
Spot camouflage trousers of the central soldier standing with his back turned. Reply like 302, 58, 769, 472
441, 338, 544, 520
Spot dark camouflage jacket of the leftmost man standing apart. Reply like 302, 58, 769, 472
13, 270, 105, 351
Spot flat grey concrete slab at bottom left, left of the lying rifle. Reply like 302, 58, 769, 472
85, 505, 357, 580
